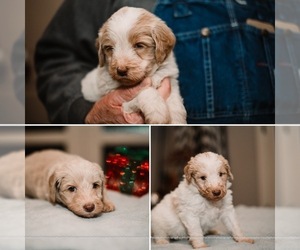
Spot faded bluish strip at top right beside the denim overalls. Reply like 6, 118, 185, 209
275, 0, 300, 124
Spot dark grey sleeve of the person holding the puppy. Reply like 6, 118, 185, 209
35, 0, 114, 124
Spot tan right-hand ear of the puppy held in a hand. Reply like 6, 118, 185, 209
152, 21, 176, 64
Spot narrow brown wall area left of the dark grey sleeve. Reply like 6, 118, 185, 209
26, 0, 63, 123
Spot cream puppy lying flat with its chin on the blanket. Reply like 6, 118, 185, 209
25, 150, 115, 218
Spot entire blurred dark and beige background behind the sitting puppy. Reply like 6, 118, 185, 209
151, 126, 275, 207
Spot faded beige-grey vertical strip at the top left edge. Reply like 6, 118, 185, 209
0, 0, 25, 124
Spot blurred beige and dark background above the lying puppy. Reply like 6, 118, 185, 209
26, 126, 149, 165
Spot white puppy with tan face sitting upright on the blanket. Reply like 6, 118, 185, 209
151, 152, 254, 248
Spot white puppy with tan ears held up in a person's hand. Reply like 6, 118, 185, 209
81, 7, 186, 124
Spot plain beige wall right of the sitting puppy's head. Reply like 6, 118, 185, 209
228, 126, 275, 206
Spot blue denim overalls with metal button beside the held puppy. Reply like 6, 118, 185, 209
154, 0, 275, 124
